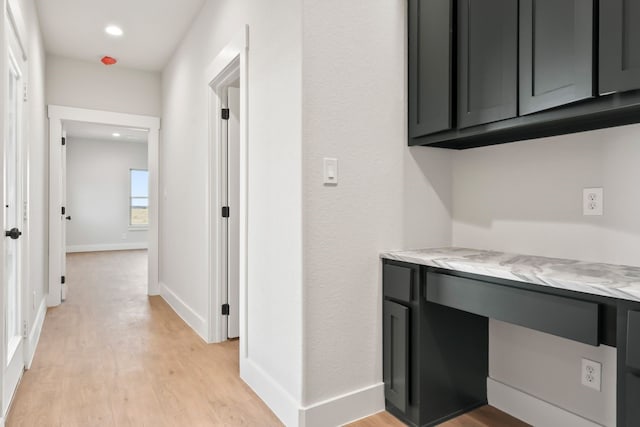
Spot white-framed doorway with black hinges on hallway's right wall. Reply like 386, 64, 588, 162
206, 27, 248, 350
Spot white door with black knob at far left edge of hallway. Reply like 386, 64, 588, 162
2, 18, 26, 415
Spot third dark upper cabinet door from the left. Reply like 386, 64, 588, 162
520, 0, 592, 115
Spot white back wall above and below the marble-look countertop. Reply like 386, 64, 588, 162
453, 125, 640, 425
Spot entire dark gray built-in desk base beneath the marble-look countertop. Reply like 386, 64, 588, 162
382, 260, 640, 427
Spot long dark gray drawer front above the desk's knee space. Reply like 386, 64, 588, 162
427, 272, 600, 346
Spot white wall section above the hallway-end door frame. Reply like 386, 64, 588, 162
46, 55, 162, 116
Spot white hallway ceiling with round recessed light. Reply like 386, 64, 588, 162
36, 0, 206, 71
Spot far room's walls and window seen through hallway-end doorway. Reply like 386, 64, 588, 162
62, 121, 150, 300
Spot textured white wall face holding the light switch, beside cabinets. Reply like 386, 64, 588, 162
303, 0, 452, 418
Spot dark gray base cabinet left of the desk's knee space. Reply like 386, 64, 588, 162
383, 260, 488, 426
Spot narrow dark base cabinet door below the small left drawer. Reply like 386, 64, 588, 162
383, 300, 410, 412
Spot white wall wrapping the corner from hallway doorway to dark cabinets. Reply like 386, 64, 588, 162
160, 0, 452, 426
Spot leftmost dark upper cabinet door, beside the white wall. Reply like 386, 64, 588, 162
409, 0, 453, 138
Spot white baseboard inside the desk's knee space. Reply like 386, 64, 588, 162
487, 378, 601, 427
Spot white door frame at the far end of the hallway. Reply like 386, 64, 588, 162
47, 105, 160, 307
